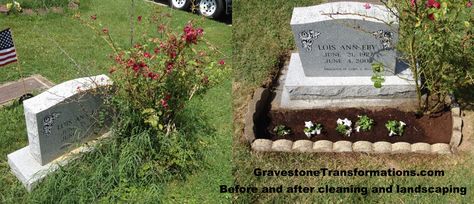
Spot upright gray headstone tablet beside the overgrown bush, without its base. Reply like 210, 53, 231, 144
23, 75, 111, 165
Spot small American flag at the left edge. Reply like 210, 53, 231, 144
0, 28, 17, 66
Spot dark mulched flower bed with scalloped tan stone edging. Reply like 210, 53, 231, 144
244, 88, 463, 154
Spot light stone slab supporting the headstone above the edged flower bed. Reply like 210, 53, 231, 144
272, 53, 417, 110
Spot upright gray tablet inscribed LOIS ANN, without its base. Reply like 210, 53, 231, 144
291, 2, 406, 77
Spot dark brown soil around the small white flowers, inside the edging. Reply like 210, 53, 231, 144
257, 108, 452, 144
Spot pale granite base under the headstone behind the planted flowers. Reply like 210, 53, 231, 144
280, 53, 417, 109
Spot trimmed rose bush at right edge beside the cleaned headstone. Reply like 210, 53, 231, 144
383, 0, 474, 114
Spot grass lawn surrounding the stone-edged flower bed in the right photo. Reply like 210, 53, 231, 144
233, 0, 474, 203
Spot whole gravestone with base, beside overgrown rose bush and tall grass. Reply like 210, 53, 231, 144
8, 75, 112, 190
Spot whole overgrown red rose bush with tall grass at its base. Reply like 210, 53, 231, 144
75, 13, 229, 180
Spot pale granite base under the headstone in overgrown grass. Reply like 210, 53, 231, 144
7, 132, 110, 192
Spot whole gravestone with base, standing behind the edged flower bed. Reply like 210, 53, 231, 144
280, 2, 416, 109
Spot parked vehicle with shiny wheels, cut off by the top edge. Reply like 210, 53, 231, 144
168, 0, 232, 18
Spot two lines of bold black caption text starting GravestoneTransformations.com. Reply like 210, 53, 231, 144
219, 168, 467, 196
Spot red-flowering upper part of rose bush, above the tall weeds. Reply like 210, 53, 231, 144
108, 22, 225, 132
